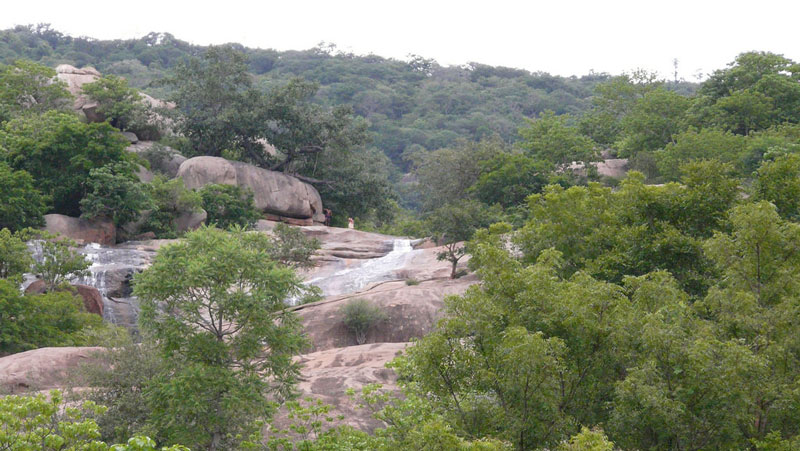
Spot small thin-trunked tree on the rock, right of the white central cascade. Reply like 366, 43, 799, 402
427, 200, 500, 279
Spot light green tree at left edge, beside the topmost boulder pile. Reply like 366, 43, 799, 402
0, 59, 72, 123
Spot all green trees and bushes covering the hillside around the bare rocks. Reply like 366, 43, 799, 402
0, 26, 800, 451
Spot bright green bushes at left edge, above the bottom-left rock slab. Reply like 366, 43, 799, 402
0, 280, 108, 354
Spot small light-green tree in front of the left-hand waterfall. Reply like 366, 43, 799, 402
31, 236, 91, 290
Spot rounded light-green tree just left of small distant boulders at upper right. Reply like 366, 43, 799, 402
519, 110, 599, 171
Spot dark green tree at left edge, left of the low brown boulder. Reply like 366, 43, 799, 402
0, 161, 47, 230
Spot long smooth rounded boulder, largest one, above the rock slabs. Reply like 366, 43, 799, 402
178, 157, 325, 222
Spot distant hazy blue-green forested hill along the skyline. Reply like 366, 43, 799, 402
0, 25, 693, 165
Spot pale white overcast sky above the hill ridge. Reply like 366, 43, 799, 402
0, 0, 800, 80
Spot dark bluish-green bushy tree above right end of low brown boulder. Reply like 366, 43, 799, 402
81, 162, 152, 225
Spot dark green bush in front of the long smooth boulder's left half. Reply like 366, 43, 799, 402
199, 185, 261, 229
